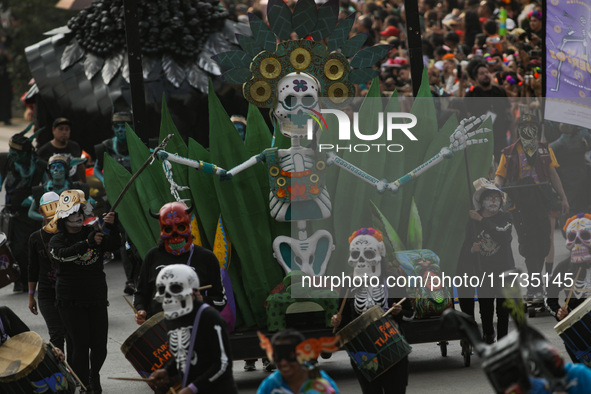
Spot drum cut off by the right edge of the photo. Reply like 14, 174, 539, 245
554, 298, 591, 367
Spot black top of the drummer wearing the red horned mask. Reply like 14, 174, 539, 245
133, 245, 227, 318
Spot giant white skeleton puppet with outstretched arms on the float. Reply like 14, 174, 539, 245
158, 73, 490, 275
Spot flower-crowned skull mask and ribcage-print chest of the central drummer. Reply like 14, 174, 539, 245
348, 228, 388, 314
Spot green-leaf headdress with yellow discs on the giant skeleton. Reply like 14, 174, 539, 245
214, 0, 391, 108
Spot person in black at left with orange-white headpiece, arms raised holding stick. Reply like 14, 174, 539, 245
49, 190, 121, 394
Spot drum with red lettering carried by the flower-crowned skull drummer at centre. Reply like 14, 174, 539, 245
337, 305, 411, 381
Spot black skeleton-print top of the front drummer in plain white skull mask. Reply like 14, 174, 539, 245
165, 300, 238, 394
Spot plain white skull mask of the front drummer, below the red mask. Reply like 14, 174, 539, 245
154, 264, 199, 319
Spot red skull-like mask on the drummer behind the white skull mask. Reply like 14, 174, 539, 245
159, 202, 193, 256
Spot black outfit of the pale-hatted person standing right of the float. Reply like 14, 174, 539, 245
456, 211, 515, 339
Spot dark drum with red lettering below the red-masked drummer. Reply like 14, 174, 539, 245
121, 312, 172, 378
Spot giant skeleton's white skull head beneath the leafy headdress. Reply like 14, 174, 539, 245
273, 72, 320, 138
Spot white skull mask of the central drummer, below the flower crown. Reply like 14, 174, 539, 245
349, 234, 386, 277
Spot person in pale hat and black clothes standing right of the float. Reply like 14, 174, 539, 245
456, 178, 515, 344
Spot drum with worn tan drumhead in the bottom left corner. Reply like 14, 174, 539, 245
0, 331, 76, 394
